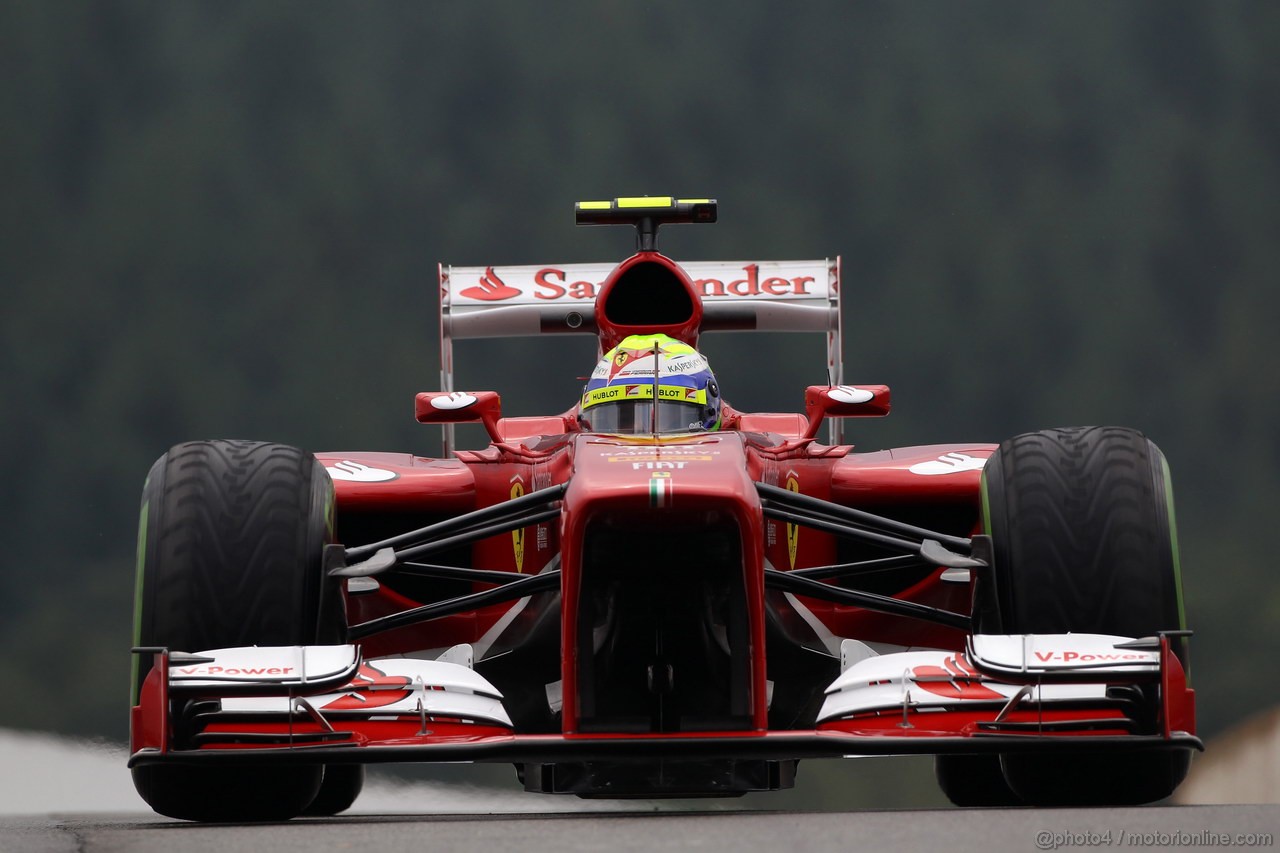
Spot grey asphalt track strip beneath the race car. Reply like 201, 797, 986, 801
0, 806, 1280, 853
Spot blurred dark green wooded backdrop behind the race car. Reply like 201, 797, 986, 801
0, 0, 1280, 768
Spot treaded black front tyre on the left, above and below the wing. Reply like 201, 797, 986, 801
132, 441, 346, 821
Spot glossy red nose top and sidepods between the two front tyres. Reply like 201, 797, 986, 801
319, 435, 977, 666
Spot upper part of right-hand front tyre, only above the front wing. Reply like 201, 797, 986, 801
983, 427, 1183, 637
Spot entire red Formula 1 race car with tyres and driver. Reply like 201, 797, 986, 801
129, 196, 1201, 821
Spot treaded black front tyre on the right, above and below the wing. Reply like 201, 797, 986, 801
975, 427, 1189, 806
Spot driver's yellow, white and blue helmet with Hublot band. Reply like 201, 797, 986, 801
579, 334, 721, 434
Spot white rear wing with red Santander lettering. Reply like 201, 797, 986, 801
440, 257, 844, 391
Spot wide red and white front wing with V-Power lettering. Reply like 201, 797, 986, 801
129, 634, 1202, 766
